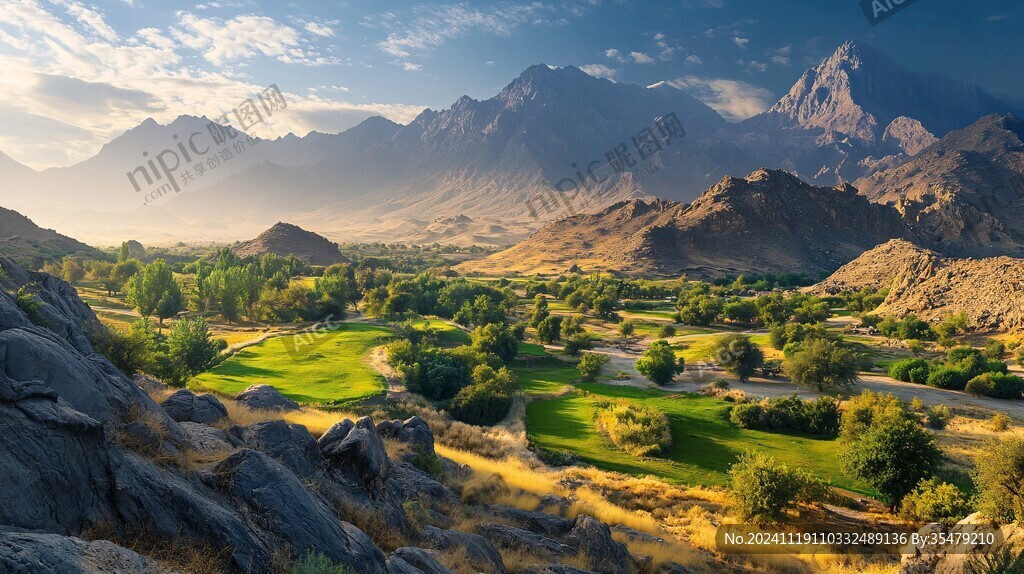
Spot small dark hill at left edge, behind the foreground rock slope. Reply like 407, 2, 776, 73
0, 208, 102, 268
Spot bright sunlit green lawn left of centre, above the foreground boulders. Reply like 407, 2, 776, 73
196, 323, 391, 403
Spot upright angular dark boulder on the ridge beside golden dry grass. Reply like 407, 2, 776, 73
318, 416, 391, 485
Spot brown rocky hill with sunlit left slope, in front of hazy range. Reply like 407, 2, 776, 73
458, 170, 909, 276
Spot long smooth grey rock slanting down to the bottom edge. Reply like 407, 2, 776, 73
215, 449, 386, 574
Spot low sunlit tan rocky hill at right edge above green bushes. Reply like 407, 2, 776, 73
812, 239, 1024, 330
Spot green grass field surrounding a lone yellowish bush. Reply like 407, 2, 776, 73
528, 380, 870, 494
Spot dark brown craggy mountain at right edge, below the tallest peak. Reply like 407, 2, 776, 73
855, 115, 1024, 256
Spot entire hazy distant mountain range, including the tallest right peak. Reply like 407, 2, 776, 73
0, 43, 1012, 244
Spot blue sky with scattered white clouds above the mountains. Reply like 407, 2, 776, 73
0, 0, 1024, 169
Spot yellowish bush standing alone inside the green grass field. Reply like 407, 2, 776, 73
597, 400, 672, 456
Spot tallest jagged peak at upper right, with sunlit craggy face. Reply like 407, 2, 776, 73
736, 42, 1014, 184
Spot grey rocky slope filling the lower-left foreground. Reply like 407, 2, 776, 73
0, 257, 671, 574
